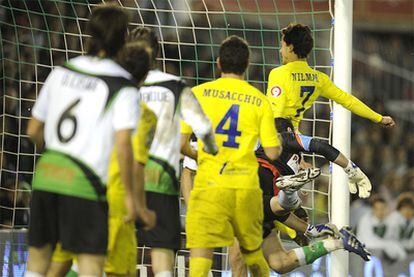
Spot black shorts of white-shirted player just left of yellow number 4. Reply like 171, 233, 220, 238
137, 191, 181, 251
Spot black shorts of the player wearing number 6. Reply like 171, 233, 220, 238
29, 190, 108, 255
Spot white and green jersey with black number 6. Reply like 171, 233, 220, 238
32, 56, 140, 200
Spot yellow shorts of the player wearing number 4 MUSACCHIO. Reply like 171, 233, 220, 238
186, 186, 263, 251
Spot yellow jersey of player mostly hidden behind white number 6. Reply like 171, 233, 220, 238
107, 102, 157, 217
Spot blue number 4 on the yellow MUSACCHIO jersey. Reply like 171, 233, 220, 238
215, 104, 241, 148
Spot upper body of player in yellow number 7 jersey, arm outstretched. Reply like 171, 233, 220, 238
266, 24, 395, 129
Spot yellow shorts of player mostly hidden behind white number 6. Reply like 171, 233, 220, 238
104, 217, 138, 275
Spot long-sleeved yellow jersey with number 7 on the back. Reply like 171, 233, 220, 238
266, 61, 382, 128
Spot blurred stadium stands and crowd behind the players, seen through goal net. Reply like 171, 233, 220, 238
0, 0, 414, 276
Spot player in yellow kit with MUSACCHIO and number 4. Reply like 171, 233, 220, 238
182, 36, 281, 277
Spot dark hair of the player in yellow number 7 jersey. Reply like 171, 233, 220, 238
282, 23, 313, 59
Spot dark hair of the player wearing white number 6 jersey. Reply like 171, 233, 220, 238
86, 4, 129, 58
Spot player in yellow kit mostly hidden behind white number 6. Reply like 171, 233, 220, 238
47, 43, 157, 277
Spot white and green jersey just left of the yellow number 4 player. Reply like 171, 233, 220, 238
140, 70, 188, 195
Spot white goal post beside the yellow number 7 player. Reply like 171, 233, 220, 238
331, 0, 353, 277
